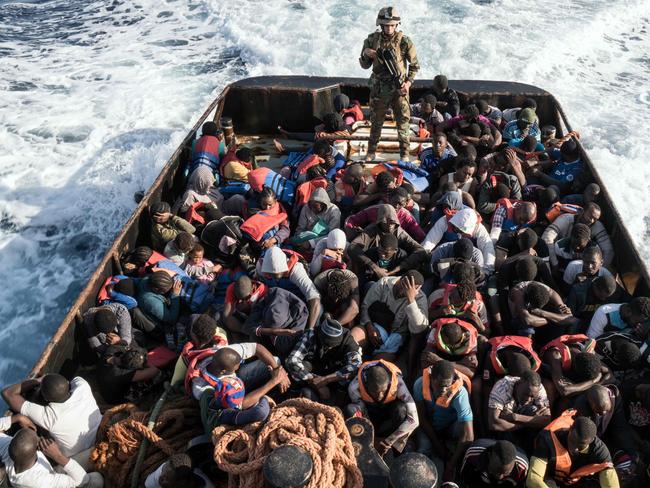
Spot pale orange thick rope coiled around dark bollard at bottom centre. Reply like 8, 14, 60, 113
212, 398, 363, 488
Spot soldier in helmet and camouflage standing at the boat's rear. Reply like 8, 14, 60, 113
359, 7, 420, 161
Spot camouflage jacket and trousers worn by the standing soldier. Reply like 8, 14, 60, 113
359, 32, 420, 156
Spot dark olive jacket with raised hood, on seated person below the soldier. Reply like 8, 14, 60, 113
348, 205, 426, 270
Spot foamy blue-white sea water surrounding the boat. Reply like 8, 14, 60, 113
0, 0, 650, 385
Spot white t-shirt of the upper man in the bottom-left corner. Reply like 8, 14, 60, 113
20, 376, 102, 457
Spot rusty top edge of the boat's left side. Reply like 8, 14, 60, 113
29, 83, 232, 378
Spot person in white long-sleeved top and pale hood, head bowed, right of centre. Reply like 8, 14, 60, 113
422, 208, 495, 274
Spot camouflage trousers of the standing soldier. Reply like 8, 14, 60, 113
368, 80, 411, 156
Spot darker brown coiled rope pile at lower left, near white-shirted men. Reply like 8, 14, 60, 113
90, 399, 202, 486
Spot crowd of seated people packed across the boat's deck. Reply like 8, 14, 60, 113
0, 75, 650, 488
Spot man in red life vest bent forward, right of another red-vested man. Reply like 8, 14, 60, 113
540, 334, 612, 400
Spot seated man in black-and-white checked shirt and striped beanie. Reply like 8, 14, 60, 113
285, 315, 361, 400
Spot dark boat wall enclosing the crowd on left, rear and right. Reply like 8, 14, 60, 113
31, 76, 650, 382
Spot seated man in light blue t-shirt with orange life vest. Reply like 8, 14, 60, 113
413, 361, 474, 481
